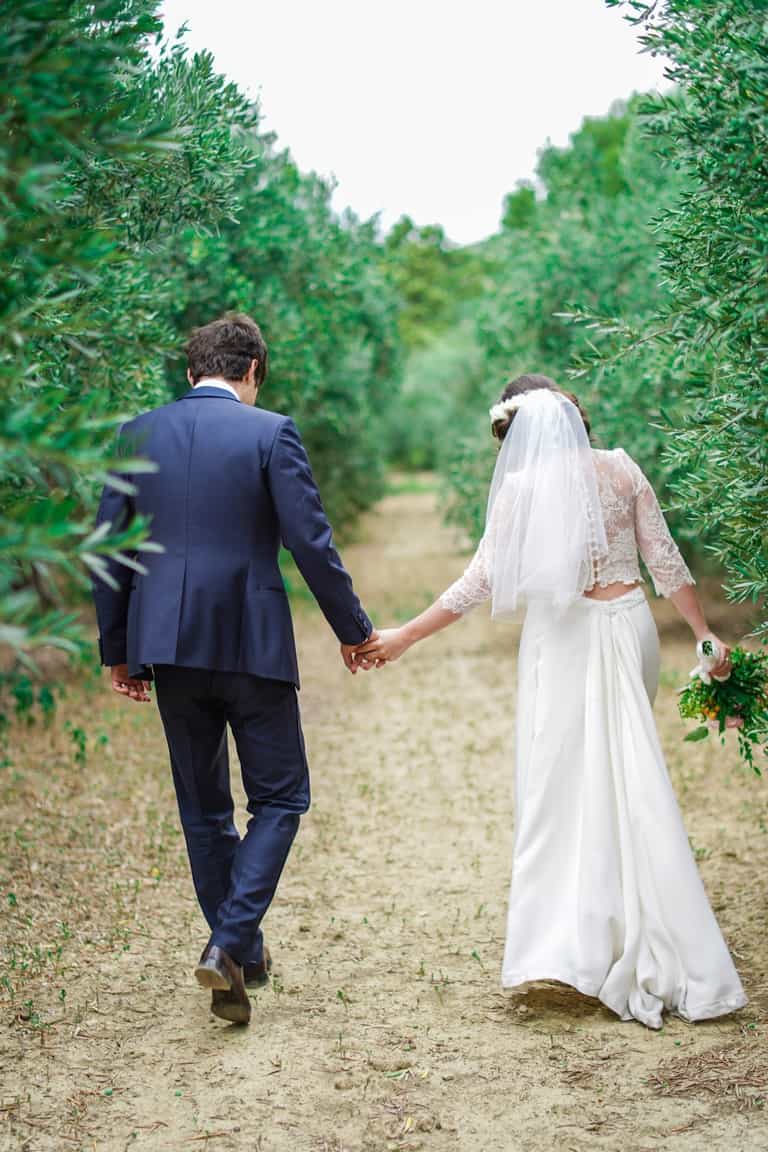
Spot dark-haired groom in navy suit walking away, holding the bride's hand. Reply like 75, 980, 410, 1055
93, 314, 373, 1023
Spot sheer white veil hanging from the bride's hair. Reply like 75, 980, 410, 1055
486, 388, 608, 616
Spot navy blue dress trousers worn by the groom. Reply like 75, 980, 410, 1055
154, 665, 310, 964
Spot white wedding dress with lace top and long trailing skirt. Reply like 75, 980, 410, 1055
440, 449, 746, 1028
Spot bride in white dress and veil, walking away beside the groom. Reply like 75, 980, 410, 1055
359, 376, 746, 1028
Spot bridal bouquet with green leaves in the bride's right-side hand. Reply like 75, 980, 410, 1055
679, 641, 768, 776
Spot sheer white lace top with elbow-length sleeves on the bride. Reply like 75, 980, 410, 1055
440, 448, 695, 615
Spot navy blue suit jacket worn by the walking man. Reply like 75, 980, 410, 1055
93, 385, 372, 685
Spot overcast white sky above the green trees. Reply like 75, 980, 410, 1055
164, 0, 663, 243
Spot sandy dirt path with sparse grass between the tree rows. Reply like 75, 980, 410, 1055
0, 479, 768, 1152
